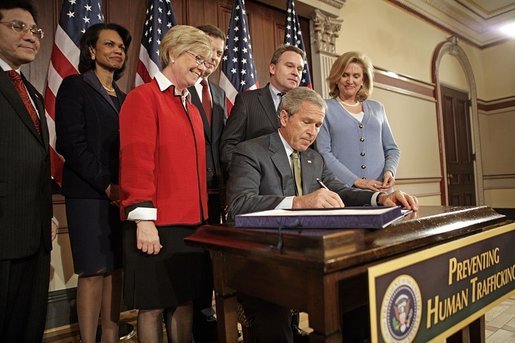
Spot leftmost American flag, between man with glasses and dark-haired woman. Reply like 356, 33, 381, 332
45, 0, 104, 185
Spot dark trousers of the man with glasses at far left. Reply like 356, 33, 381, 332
0, 243, 50, 343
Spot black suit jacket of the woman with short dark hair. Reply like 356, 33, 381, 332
55, 71, 125, 199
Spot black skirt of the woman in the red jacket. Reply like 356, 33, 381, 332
123, 221, 208, 310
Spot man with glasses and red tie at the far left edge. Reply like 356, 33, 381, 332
0, 0, 57, 342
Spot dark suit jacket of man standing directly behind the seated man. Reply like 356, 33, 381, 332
220, 84, 279, 172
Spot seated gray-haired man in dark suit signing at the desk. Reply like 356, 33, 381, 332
227, 87, 418, 343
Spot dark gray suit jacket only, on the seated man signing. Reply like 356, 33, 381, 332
227, 132, 374, 218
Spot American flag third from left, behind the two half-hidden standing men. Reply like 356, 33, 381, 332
220, 0, 257, 113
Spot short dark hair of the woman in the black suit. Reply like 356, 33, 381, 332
79, 23, 132, 80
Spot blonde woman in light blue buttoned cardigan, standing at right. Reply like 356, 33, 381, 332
316, 51, 400, 192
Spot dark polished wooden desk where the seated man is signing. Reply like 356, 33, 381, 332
187, 206, 507, 343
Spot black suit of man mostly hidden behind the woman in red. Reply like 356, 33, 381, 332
189, 82, 227, 342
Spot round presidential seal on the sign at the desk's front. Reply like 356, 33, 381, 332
381, 274, 422, 342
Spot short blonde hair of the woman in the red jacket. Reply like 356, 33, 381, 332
159, 25, 212, 69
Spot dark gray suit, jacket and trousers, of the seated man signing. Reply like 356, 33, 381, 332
227, 132, 374, 343
